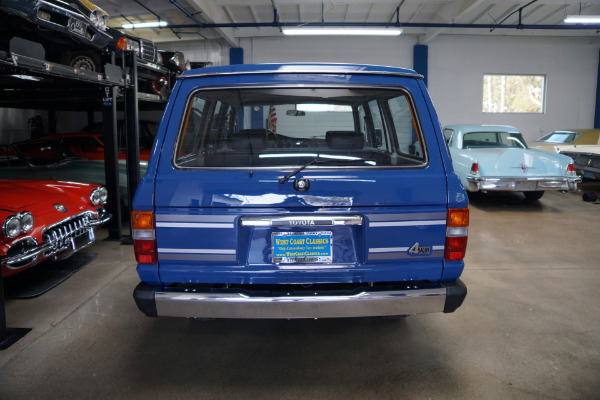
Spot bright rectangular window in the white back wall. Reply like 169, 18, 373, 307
482, 74, 546, 114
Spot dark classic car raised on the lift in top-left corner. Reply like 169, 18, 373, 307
0, 0, 112, 70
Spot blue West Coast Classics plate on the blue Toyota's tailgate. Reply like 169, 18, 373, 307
271, 231, 333, 264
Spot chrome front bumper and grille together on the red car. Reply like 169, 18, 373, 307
0, 210, 112, 269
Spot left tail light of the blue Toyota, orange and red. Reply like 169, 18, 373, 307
131, 211, 158, 264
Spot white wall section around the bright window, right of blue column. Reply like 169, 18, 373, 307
428, 36, 600, 141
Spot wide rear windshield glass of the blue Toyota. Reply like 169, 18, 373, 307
174, 87, 427, 168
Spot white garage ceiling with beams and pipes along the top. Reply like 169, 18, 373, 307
94, 0, 600, 46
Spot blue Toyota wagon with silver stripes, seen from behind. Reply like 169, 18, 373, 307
132, 63, 469, 319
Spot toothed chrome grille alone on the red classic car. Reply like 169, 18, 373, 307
42, 211, 96, 256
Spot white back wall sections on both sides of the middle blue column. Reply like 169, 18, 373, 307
240, 35, 600, 141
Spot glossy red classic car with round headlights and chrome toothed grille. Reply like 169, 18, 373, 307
0, 179, 111, 277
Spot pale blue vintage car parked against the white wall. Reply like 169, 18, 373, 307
444, 125, 581, 200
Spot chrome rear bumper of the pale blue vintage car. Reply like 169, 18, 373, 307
465, 176, 581, 192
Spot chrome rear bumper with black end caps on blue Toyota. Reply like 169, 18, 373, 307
133, 279, 467, 319
